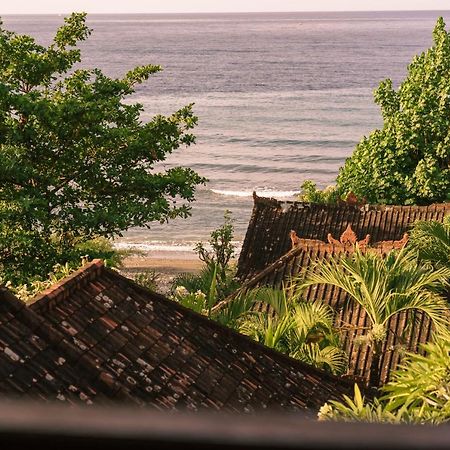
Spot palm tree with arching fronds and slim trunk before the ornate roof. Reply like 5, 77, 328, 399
302, 248, 450, 386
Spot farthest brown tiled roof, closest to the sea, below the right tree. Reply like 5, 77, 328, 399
238, 195, 450, 280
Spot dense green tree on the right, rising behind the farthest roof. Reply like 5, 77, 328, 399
337, 17, 450, 204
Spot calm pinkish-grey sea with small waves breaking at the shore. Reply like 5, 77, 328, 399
3, 11, 450, 256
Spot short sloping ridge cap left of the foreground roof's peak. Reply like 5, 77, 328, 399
28, 259, 105, 313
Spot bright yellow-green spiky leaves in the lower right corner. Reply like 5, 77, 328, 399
319, 336, 450, 424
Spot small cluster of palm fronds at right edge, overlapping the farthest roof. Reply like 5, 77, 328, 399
408, 215, 450, 268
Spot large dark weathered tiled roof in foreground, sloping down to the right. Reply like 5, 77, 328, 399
0, 261, 353, 412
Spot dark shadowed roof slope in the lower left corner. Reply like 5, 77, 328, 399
0, 287, 134, 404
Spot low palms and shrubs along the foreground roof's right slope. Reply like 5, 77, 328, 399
173, 274, 347, 374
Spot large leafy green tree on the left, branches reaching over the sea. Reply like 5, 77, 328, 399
0, 13, 205, 282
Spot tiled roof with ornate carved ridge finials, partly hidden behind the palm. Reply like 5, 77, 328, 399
230, 240, 438, 383
